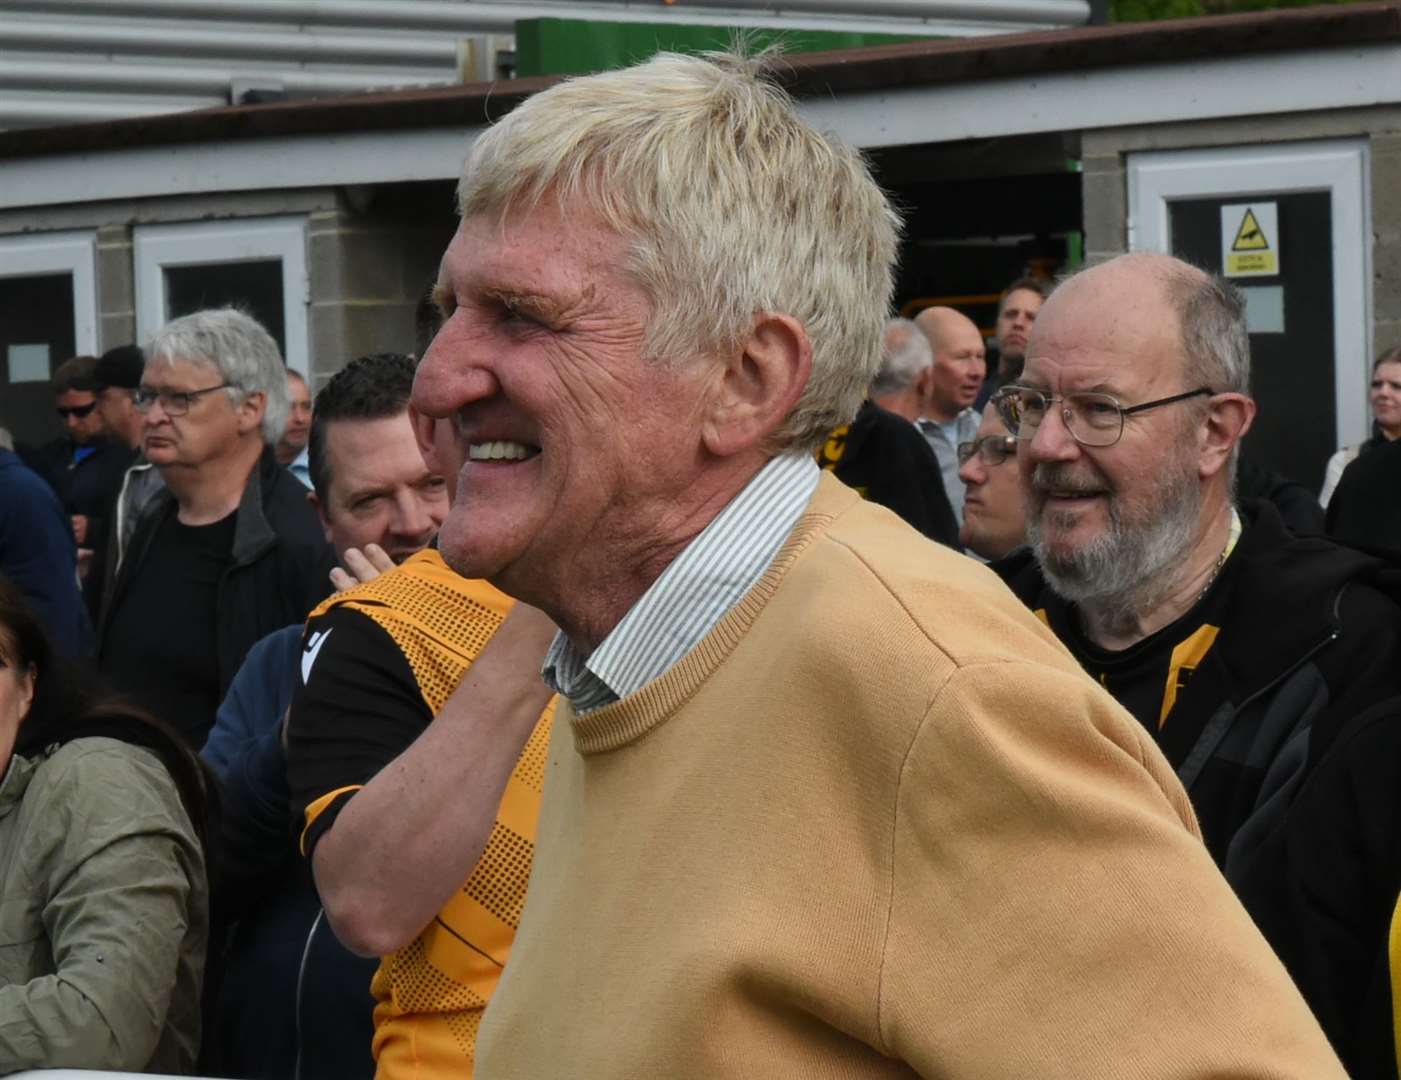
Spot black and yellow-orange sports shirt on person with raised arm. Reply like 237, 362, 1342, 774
287, 549, 555, 1080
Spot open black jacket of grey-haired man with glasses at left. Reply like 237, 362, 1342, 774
98, 447, 335, 696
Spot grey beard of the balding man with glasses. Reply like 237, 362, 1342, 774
1027, 465, 1202, 635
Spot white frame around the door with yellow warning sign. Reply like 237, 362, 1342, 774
1128, 139, 1373, 445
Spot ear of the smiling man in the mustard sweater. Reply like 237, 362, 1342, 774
701, 311, 813, 457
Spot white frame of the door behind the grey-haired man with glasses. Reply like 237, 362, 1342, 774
132, 217, 311, 377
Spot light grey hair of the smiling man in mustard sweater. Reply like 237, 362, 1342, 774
458, 53, 899, 452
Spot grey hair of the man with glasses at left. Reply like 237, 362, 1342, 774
146, 308, 290, 445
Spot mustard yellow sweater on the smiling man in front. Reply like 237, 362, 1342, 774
478, 476, 1344, 1080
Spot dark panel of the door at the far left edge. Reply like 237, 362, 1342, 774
0, 273, 74, 445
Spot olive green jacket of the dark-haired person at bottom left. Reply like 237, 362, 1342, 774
0, 738, 209, 1073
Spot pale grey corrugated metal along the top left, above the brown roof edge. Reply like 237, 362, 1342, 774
0, 0, 1090, 129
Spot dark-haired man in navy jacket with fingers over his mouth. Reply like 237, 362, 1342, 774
200, 353, 448, 1080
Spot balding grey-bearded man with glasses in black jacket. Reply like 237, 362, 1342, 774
993, 254, 1401, 1076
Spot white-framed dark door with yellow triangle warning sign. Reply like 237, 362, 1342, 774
1128, 139, 1372, 490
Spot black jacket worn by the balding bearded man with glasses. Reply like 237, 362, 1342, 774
996, 503, 1401, 1076
